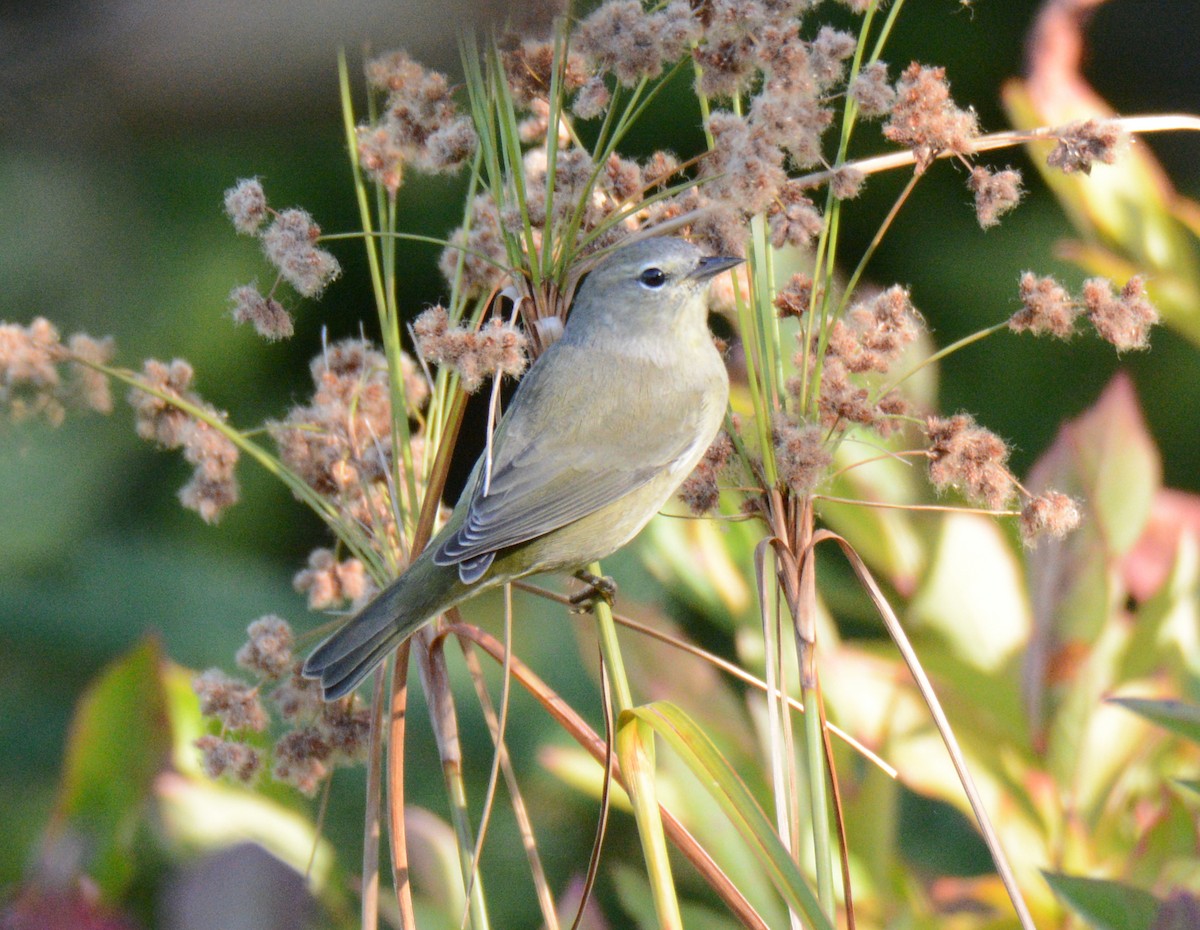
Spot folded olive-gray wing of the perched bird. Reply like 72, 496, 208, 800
433, 344, 698, 573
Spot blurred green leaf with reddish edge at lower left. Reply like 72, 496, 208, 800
48, 638, 170, 900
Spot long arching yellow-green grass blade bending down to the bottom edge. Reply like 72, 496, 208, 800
622, 701, 832, 930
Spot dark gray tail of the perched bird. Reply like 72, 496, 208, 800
301, 552, 470, 701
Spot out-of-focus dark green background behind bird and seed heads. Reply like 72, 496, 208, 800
0, 0, 1200, 926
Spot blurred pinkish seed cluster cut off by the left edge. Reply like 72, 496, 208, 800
0, 317, 113, 426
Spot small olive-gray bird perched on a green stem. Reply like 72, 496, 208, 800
304, 239, 740, 701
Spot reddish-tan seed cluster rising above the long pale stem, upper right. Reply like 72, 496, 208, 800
883, 61, 979, 172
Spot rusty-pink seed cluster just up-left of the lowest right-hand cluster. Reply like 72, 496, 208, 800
925, 414, 1015, 510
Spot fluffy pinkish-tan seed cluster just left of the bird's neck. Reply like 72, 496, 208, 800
413, 306, 529, 392
